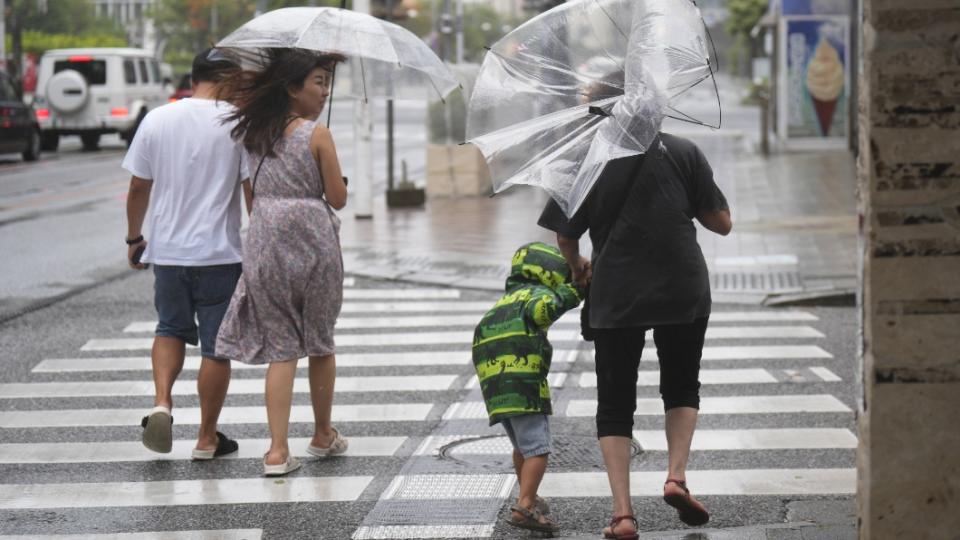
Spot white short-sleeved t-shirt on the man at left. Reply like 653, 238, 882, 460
123, 98, 248, 266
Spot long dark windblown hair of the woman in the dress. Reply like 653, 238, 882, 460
217, 49, 346, 156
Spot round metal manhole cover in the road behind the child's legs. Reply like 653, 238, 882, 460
439, 435, 643, 473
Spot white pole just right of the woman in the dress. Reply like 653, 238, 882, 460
350, 0, 373, 219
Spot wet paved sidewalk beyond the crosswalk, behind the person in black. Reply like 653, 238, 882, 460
342, 127, 857, 303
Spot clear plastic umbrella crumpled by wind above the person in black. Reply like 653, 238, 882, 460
467, 0, 719, 216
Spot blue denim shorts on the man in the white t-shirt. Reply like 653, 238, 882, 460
153, 263, 242, 358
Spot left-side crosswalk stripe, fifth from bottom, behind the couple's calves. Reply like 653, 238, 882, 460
0, 375, 457, 399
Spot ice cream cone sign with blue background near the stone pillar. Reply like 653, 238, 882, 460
780, 16, 849, 139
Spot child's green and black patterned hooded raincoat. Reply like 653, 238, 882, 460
473, 242, 583, 425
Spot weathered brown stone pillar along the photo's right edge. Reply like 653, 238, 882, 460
858, 0, 960, 539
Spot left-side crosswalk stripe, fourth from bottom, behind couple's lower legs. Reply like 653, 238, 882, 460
0, 403, 433, 428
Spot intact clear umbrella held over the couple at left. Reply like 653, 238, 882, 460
216, 7, 460, 99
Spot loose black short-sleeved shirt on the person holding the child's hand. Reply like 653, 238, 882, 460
538, 133, 728, 328
